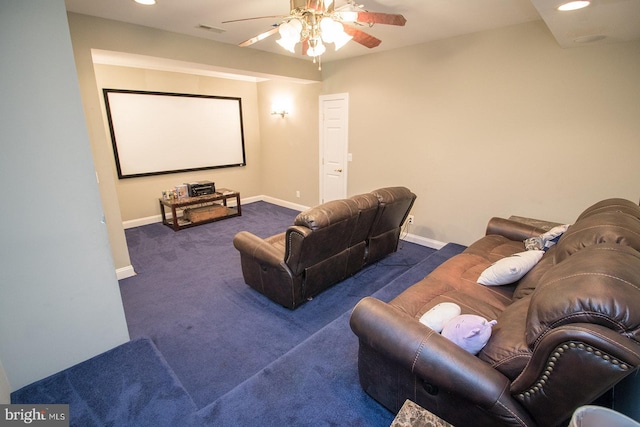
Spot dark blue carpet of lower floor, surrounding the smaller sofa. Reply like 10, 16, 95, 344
121, 202, 434, 407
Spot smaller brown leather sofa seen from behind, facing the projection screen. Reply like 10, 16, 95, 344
233, 187, 416, 309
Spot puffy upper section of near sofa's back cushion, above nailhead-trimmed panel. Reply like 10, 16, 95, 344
526, 243, 640, 348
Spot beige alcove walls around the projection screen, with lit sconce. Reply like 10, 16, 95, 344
94, 64, 320, 222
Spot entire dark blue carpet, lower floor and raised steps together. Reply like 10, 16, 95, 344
12, 202, 464, 426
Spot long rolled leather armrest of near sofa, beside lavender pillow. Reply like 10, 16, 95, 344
350, 297, 517, 410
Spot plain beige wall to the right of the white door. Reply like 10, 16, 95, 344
323, 21, 640, 244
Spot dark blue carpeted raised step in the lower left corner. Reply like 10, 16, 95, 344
11, 339, 196, 427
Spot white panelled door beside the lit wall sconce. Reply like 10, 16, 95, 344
320, 93, 349, 203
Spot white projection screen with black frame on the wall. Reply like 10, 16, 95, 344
103, 89, 246, 179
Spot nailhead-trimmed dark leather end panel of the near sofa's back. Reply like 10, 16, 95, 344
511, 323, 640, 425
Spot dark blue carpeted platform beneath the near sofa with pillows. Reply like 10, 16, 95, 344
194, 244, 464, 427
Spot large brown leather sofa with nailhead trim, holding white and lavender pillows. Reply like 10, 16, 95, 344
350, 199, 640, 427
